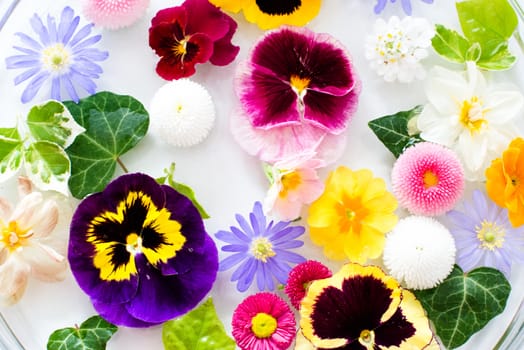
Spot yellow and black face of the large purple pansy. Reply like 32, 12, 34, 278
87, 191, 186, 281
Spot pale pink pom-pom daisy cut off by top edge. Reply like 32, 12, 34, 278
84, 0, 149, 29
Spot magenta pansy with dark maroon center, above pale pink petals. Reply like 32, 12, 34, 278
237, 27, 360, 134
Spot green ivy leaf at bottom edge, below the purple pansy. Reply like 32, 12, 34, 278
47, 316, 118, 350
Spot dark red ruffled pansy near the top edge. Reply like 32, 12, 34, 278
149, 0, 240, 80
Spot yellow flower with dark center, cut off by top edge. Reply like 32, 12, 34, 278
209, 0, 322, 29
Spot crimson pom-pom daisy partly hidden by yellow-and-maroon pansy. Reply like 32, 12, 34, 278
284, 260, 332, 310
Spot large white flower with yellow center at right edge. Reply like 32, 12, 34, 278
417, 62, 524, 181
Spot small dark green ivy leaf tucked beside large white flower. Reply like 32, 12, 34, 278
368, 106, 422, 158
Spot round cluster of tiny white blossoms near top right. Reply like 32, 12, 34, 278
366, 16, 435, 83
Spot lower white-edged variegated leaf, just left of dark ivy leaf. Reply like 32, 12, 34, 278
23, 141, 71, 196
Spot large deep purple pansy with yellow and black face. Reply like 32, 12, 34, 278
68, 173, 218, 327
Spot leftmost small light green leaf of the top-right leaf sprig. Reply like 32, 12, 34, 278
431, 24, 471, 63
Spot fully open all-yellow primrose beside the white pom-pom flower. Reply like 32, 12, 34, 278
307, 166, 398, 263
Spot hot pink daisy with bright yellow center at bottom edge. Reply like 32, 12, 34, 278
231, 293, 296, 350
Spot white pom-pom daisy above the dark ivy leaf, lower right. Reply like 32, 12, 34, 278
384, 216, 456, 289
